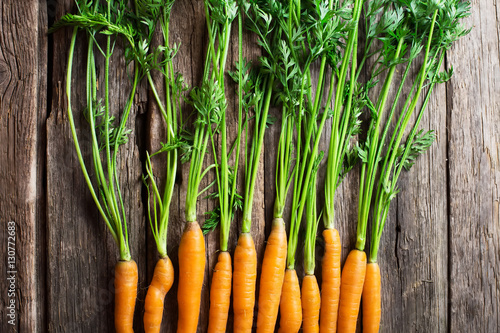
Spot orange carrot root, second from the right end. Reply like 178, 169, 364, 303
337, 250, 366, 333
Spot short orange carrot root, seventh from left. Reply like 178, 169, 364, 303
278, 269, 302, 333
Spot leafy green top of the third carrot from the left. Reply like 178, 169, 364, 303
186, 0, 237, 224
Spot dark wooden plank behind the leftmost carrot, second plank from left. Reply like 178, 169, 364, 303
47, 0, 146, 332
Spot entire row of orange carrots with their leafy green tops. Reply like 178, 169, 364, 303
52, 0, 470, 333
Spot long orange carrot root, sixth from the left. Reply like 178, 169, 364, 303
257, 218, 287, 333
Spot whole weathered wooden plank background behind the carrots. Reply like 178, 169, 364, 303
0, 0, 500, 333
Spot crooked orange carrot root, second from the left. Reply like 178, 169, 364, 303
144, 257, 174, 333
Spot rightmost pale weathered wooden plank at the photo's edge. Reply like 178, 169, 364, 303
447, 0, 500, 332
